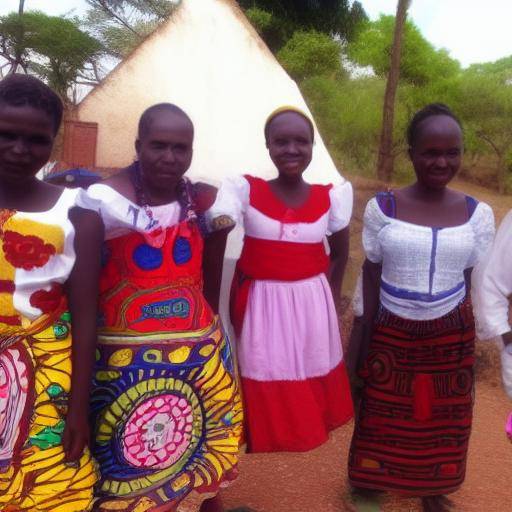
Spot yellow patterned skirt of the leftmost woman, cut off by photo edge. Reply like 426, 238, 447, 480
0, 311, 98, 512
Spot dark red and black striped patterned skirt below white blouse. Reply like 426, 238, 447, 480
349, 300, 475, 496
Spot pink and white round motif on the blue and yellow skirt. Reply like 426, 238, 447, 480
123, 393, 193, 469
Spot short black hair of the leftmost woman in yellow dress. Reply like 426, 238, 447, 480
0, 73, 64, 134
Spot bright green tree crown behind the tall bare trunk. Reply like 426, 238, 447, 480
347, 15, 460, 86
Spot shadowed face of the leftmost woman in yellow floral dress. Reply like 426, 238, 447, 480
0, 103, 55, 186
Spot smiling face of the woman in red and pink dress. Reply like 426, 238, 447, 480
266, 112, 313, 179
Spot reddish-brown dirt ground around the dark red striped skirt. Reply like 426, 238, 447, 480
223, 381, 512, 512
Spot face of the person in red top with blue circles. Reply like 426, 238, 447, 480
135, 110, 194, 190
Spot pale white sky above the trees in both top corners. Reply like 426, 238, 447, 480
0, 0, 512, 66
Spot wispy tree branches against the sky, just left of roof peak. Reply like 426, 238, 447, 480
84, 0, 179, 59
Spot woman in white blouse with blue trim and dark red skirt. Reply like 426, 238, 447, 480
349, 104, 494, 512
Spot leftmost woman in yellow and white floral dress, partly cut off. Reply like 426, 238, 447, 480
0, 75, 102, 512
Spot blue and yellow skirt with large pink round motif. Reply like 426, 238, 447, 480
91, 318, 243, 512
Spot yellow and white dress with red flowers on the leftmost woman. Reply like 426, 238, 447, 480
0, 189, 97, 512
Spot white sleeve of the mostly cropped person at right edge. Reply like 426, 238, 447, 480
471, 211, 512, 340
